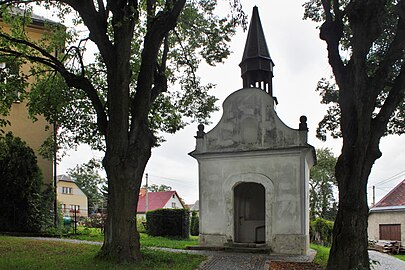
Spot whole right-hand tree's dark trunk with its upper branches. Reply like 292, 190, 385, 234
320, 0, 405, 270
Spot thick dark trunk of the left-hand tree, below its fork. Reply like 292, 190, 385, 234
99, 125, 152, 262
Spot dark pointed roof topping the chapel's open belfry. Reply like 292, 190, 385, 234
242, 6, 274, 65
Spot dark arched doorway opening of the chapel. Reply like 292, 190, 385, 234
234, 182, 266, 243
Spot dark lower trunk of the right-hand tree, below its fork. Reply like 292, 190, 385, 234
327, 153, 370, 270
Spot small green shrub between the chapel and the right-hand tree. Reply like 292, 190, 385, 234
310, 218, 333, 246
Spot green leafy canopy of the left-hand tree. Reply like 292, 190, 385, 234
0, 0, 246, 150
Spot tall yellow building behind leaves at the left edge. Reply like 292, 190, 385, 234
0, 11, 59, 184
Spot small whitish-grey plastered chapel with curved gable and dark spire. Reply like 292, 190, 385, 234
190, 7, 316, 255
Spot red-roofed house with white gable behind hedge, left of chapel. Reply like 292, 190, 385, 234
137, 188, 185, 218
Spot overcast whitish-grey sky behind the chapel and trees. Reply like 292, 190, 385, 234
58, 0, 405, 203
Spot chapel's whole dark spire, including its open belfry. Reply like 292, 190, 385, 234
239, 6, 274, 96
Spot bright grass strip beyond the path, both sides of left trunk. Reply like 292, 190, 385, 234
69, 227, 198, 249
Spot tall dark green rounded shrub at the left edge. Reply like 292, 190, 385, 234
0, 133, 53, 232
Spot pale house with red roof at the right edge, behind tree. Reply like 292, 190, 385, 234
368, 180, 405, 245
